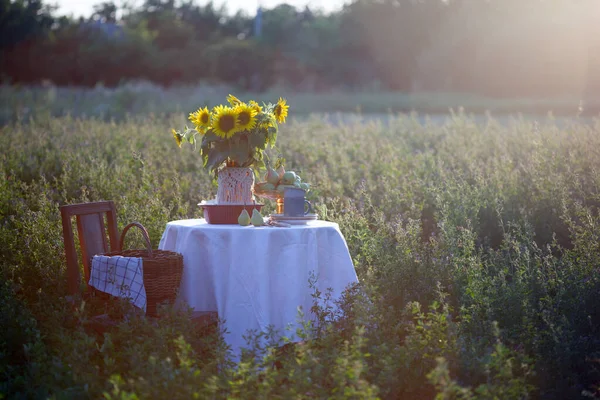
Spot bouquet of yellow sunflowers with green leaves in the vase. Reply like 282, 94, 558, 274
172, 94, 289, 175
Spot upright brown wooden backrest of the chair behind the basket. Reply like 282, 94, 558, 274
60, 201, 119, 294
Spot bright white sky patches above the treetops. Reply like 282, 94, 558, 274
54, 0, 347, 17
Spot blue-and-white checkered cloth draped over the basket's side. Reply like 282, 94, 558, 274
89, 256, 146, 312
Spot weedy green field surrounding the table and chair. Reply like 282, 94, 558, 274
0, 95, 600, 399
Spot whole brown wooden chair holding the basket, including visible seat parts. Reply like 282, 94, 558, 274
60, 201, 218, 331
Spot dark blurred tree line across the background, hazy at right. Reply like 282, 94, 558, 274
0, 0, 600, 97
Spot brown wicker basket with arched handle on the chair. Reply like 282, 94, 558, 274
105, 222, 183, 317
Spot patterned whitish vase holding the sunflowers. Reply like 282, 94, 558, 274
217, 167, 254, 204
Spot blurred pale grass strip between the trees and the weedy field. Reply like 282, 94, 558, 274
0, 82, 600, 124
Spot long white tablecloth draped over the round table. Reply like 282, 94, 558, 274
159, 219, 358, 357
